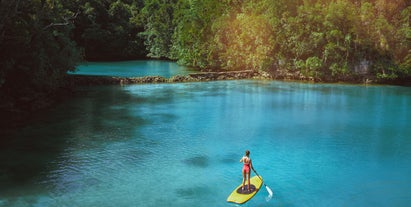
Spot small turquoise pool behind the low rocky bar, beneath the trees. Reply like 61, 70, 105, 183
70, 60, 195, 78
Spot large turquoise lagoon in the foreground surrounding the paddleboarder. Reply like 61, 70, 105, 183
0, 80, 411, 207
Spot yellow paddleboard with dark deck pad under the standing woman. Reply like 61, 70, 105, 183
227, 176, 263, 204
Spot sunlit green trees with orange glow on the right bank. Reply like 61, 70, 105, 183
137, 0, 411, 81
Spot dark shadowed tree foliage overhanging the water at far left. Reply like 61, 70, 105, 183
0, 0, 82, 99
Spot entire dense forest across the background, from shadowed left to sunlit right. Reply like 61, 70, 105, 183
0, 0, 411, 112
